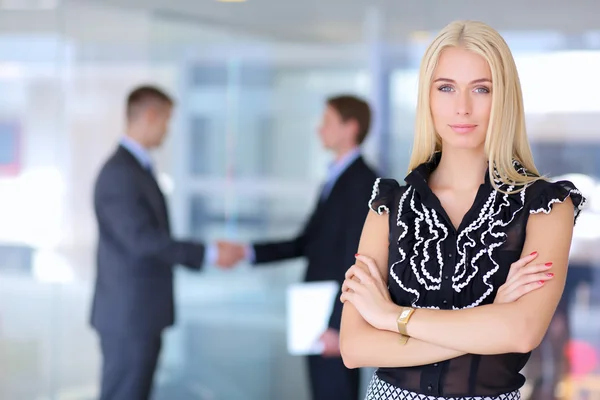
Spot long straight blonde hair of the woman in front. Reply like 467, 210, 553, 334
408, 21, 542, 191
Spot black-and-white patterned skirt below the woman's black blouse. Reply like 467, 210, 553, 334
365, 373, 521, 400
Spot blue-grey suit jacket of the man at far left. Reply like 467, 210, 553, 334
91, 146, 204, 335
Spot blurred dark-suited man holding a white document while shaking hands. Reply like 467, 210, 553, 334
223, 95, 377, 400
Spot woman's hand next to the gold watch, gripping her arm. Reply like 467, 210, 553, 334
340, 254, 400, 332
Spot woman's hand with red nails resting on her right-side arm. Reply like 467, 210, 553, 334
494, 252, 554, 304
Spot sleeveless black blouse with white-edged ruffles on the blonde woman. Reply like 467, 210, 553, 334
369, 153, 585, 397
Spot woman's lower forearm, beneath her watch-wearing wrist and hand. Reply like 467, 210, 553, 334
340, 318, 465, 368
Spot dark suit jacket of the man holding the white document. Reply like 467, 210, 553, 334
254, 157, 377, 330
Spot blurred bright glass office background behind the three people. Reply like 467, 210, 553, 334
0, 0, 600, 400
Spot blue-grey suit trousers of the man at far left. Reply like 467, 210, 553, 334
100, 333, 161, 400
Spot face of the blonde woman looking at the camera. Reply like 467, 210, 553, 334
430, 47, 492, 149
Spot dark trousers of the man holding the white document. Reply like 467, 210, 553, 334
308, 356, 360, 400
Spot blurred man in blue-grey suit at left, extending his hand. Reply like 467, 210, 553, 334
91, 86, 239, 400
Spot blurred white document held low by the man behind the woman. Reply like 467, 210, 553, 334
287, 281, 340, 355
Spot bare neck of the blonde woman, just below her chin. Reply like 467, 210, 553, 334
429, 149, 488, 190
